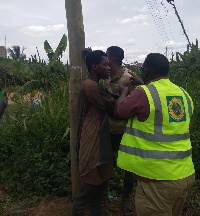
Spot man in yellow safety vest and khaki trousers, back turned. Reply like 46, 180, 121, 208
117, 53, 195, 216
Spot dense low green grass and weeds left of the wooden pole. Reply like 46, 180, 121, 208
0, 82, 71, 197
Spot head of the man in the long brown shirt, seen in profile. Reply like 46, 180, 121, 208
85, 50, 110, 79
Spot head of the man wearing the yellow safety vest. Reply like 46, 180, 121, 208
141, 53, 169, 83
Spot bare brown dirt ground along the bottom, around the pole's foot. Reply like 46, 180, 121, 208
0, 192, 132, 216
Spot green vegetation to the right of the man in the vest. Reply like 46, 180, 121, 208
169, 57, 200, 179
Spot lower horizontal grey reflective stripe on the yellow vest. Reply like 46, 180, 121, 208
119, 145, 192, 160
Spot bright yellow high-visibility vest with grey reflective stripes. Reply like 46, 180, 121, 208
117, 79, 195, 180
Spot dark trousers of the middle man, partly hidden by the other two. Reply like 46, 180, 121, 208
111, 134, 136, 200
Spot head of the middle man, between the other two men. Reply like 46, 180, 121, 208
106, 46, 124, 65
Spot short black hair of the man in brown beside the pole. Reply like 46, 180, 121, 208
85, 50, 107, 72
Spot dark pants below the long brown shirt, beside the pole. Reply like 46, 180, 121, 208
72, 181, 107, 216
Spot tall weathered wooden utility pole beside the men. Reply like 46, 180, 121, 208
65, 0, 86, 198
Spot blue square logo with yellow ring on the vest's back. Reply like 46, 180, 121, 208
167, 96, 186, 122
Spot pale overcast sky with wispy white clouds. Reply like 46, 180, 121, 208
0, 0, 200, 63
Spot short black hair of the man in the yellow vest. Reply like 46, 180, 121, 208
143, 53, 169, 78
